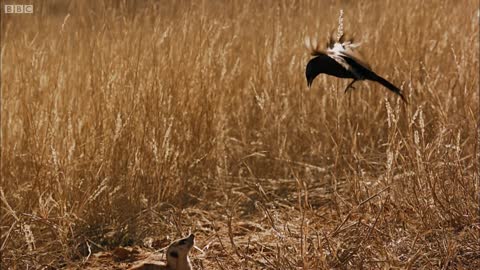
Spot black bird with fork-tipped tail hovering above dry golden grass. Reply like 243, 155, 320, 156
305, 35, 406, 102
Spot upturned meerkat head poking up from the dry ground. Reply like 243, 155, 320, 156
167, 234, 195, 270
